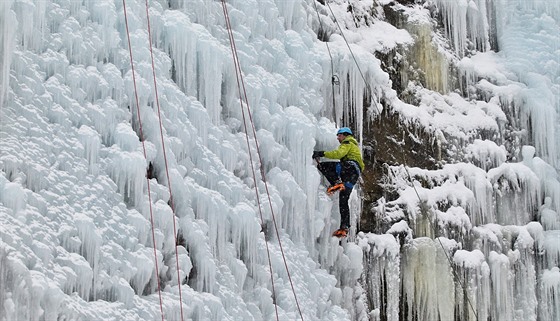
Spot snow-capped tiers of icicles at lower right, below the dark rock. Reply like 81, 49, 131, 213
385, 146, 558, 320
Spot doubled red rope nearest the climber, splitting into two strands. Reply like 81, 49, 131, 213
222, 0, 303, 320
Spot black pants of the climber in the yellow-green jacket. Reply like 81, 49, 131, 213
317, 161, 360, 228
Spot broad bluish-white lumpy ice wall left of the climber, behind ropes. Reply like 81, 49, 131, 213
0, 0, 381, 320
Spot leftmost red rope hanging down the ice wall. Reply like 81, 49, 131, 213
123, 0, 164, 321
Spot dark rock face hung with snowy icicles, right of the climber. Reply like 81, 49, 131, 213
354, 1, 560, 320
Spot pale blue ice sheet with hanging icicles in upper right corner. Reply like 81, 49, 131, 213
435, 0, 560, 168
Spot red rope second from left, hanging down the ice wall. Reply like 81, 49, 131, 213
142, 0, 184, 320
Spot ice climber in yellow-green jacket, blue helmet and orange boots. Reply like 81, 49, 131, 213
312, 127, 364, 237
